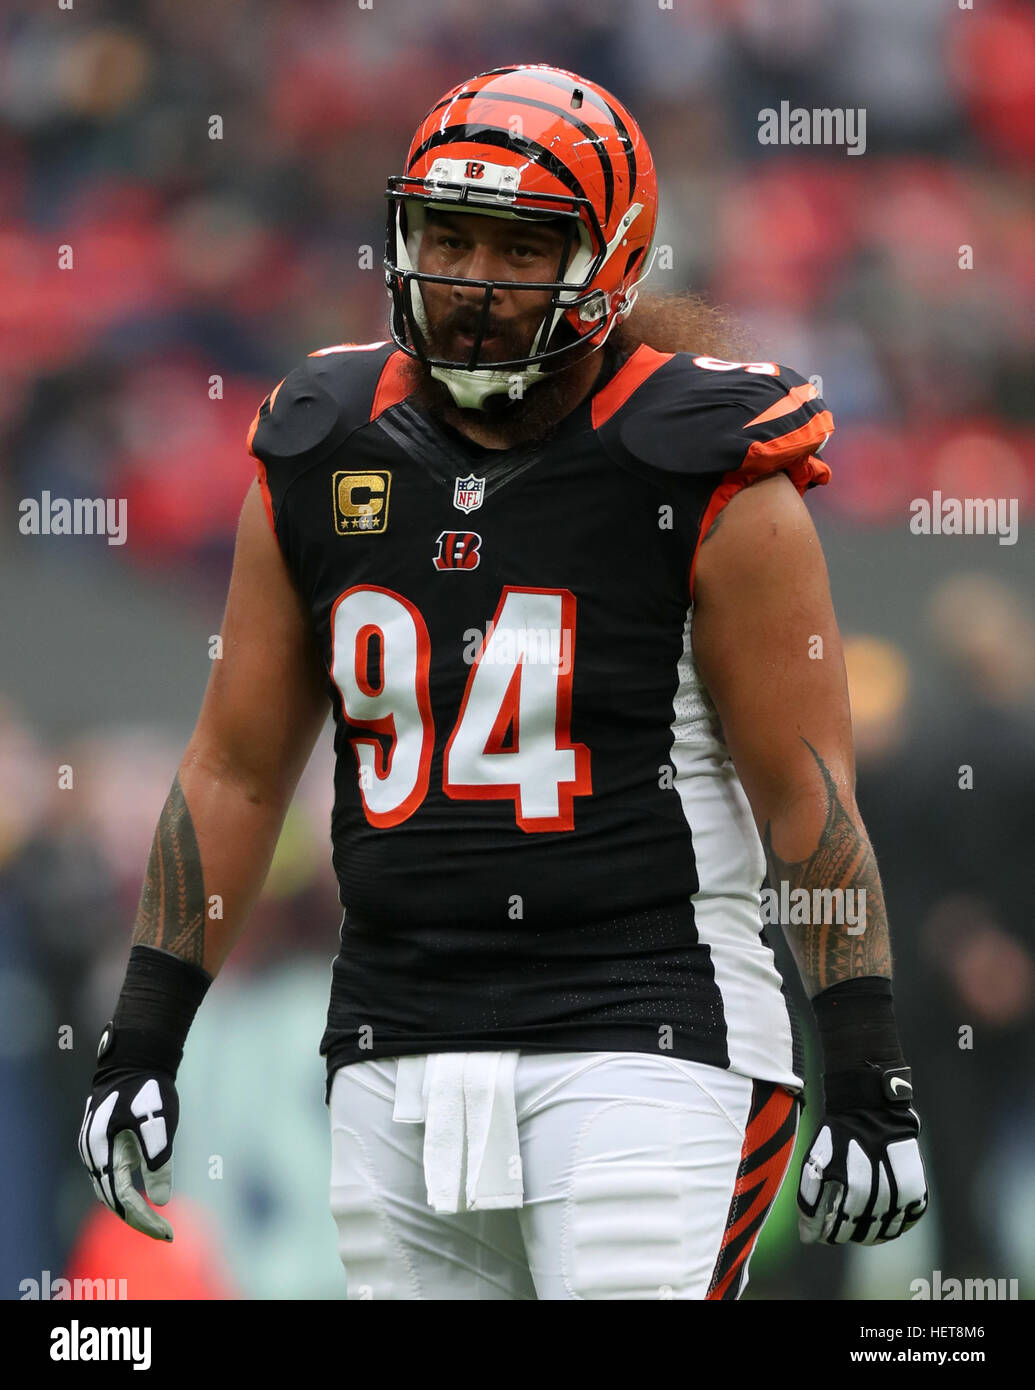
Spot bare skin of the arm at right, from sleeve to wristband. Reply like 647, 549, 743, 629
693, 473, 892, 998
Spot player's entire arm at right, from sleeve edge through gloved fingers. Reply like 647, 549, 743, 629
693, 473, 927, 1244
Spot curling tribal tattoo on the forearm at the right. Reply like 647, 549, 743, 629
763, 738, 892, 998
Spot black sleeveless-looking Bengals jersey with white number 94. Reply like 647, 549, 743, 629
249, 343, 834, 1087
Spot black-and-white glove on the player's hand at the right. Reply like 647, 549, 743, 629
797, 1066, 928, 1245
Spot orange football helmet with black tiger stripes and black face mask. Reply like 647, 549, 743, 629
385, 63, 657, 409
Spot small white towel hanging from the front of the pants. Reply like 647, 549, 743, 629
392, 1052, 524, 1212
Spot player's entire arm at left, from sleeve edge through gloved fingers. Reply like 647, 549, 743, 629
79, 484, 329, 1240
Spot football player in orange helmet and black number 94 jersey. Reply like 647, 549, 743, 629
79, 65, 927, 1300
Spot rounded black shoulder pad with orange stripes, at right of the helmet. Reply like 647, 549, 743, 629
614, 352, 834, 491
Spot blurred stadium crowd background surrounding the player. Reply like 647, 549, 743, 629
0, 0, 1035, 1298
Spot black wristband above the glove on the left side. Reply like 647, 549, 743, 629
93, 945, 213, 1086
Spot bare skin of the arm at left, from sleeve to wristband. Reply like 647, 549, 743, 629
132, 482, 329, 976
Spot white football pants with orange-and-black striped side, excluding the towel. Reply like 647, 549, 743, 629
329, 1052, 799, 1300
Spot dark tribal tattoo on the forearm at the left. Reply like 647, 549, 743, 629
132, 774, 206, 966
